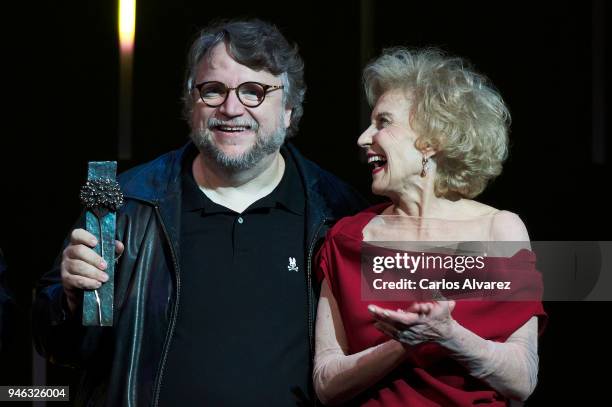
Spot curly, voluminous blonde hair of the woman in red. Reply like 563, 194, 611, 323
363, 48, 510, 200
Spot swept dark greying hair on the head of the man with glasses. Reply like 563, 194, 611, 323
183, 19, 306, 136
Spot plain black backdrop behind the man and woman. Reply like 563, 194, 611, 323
0, 0, 612, 406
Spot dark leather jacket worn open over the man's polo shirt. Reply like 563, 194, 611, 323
33, 143, 366, 406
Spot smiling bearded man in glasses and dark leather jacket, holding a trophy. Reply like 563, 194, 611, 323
35, 20, 364, 406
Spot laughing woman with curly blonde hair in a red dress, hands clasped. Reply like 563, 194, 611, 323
313, 48, 545, 406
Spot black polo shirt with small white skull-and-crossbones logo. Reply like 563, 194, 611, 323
160, 151, 310, 406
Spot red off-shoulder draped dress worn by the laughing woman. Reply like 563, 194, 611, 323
317, 204, 546, 407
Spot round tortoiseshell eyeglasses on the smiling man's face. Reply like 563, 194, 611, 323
194, 81, 284, 107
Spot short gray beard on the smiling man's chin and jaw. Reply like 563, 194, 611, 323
189, 125, 287, 174
